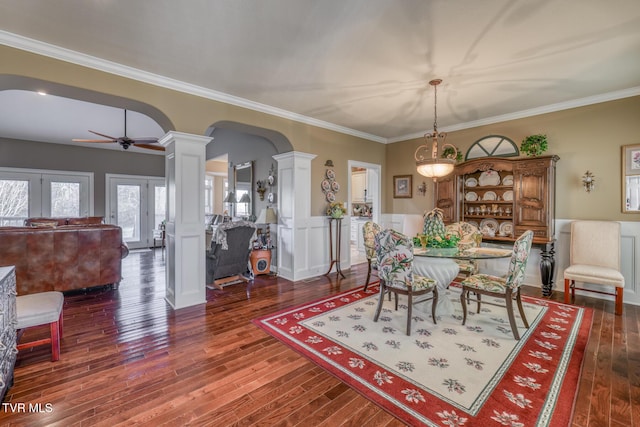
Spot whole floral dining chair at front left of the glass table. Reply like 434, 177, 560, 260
373, 229, 438, 335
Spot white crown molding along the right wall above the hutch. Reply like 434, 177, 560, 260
388, 86, 640, 144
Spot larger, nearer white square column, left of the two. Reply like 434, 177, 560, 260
160, 132, 212, 309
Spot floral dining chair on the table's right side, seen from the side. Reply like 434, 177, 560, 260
460, 230, 533, 340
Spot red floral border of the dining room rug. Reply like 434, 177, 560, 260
251, 282, 593, 426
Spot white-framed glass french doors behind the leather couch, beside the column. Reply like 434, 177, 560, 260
106, 174, 166, 249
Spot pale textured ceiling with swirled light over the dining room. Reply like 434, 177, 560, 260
0, 0, 640, 147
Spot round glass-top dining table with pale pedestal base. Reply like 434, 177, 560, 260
413, 247, 513, 315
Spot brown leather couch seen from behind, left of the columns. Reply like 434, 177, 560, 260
0, 219, 129, 295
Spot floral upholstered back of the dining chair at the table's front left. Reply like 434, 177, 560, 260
375, 229, 413, 289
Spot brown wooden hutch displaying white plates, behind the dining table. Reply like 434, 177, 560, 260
435, 156, 559, 296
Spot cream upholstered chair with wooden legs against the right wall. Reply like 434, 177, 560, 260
564, 221, 624, 315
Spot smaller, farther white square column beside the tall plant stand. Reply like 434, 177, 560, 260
273, 151, 316, 281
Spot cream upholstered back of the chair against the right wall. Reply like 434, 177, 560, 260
569, 221, 620, 271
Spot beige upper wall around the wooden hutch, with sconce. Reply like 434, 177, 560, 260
383, 96, 640, 221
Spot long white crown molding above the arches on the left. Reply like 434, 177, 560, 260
0, 30, 387, 143
